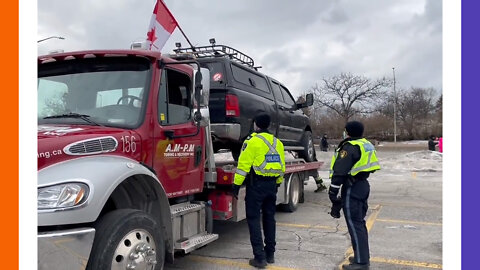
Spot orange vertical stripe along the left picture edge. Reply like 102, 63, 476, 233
0, 0, 19, 269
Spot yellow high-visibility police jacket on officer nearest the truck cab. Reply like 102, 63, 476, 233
234, 133, 285, 185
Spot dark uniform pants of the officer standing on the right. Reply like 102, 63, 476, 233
342, 180, 370, 264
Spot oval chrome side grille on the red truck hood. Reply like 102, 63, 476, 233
63, 136, 118, 156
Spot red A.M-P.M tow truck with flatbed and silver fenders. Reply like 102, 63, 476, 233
37, 50, 322, 270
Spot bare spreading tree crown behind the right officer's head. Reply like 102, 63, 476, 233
311, 73, 391, 123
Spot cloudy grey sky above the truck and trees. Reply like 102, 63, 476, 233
37, 0, 442, 96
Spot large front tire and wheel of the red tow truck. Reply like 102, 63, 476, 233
87, 209, 165, 270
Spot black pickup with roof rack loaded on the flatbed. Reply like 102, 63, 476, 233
170, 44, 316, 161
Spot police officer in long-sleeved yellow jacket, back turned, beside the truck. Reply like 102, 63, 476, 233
233, 114, 285, 268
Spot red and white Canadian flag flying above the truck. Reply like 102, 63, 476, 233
147, 0, 178, 51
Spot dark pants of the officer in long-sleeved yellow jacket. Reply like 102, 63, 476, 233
245, 177, 277, 260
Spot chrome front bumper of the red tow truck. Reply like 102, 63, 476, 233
37, 228, 95, 270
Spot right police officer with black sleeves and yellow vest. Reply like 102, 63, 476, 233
328, 121, 380, 270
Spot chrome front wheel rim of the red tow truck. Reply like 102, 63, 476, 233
111, 229, 157, 270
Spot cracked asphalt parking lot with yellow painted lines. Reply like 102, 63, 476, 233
165, 150, 442, 270
